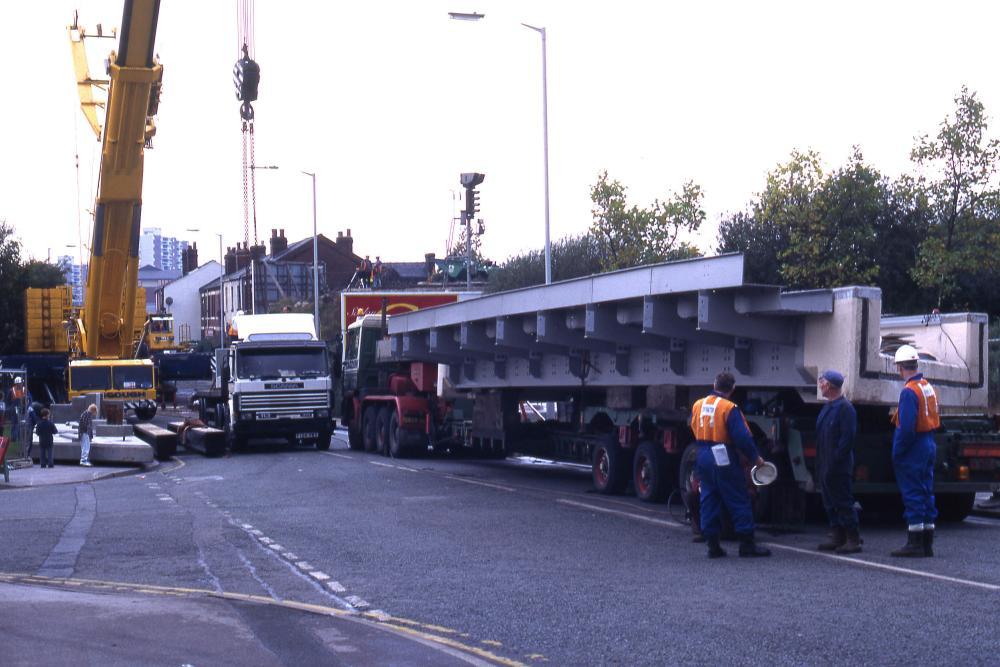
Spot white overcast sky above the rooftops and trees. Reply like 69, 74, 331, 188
0, 0, 1000, 262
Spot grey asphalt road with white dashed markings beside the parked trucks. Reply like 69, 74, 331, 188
0, 430, 1000, 665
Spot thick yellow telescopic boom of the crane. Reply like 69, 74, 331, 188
78, 0, 163, 359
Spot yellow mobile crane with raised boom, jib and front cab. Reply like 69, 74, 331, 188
68, 0, 163, 417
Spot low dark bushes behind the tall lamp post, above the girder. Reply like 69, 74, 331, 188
486, 234, 601, 292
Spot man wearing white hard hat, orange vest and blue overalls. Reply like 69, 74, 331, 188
892, 345, 941, 558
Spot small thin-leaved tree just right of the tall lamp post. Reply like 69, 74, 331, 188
590, 171, 705, 271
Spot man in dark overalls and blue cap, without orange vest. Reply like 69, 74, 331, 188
816, 370, 861, 554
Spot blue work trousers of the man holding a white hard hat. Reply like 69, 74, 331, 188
695, 444, 753, 537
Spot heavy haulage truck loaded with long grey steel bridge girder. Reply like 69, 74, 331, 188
342, 255, 1000, 522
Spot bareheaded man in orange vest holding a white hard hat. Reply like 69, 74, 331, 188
691, 373, 771, 558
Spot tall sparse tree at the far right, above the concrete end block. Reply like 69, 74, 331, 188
910, 86, 1000, 307
